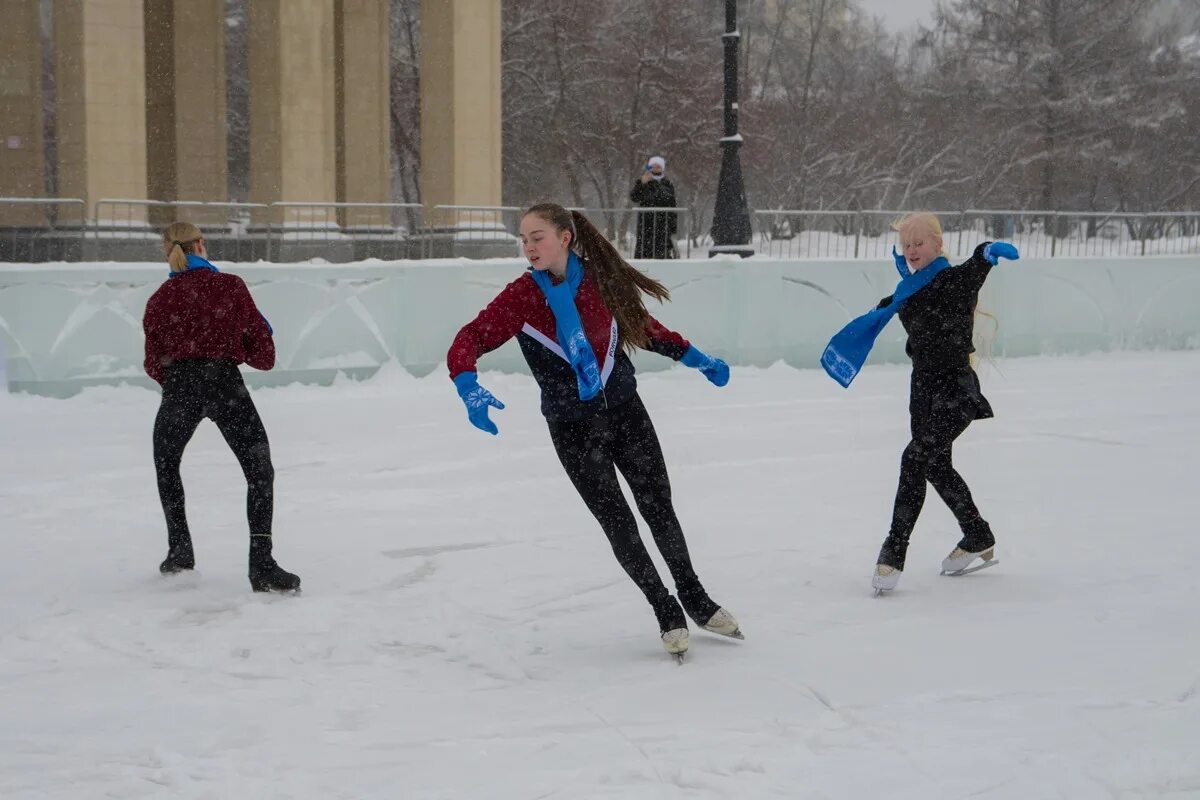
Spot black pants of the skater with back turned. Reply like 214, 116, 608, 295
154, 359, 275, 552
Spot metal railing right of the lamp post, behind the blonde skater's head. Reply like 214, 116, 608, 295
755, 209, 1200, 258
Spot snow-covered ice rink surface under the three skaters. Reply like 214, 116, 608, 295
0, 353, 1200, 800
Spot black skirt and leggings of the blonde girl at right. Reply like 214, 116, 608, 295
889, 369, 991, 541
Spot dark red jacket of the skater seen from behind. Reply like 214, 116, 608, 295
142, 269, 275, 384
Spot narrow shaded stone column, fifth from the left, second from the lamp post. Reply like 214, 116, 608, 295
335, 0, 392, 228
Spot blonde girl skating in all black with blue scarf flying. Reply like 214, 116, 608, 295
821, 213, 1019, 594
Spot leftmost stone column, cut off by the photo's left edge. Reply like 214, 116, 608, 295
0, 0, 47, 227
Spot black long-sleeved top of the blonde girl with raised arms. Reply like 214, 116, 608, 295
880, 242, 992, 425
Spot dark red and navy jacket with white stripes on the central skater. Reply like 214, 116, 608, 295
446, 271, 688, 422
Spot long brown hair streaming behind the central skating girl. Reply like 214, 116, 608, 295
526, 203, 671, 353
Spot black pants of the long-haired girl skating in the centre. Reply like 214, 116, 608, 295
550, 395, 719, 631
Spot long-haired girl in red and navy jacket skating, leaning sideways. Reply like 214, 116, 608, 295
446, 203, 742, 657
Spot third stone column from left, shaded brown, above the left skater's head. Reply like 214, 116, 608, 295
145, 0, 229, 223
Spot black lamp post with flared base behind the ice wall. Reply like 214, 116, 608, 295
708, 0, 754, 258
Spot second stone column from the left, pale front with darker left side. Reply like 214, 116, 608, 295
54, 0, 148, 224
